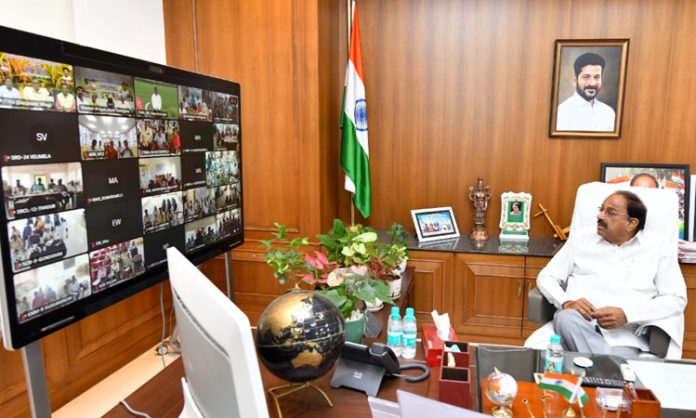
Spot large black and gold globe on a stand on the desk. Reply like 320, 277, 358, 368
256, 290, 345, 416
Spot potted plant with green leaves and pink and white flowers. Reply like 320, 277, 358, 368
261, 221, 393, 342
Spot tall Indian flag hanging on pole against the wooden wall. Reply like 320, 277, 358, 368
341, 0, 372, 218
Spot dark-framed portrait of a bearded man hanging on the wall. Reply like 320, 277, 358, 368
549, 39, 629, 139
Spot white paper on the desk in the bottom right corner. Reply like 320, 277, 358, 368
628, 360, 696, 411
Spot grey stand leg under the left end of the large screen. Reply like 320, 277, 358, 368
22, 340, 51, 418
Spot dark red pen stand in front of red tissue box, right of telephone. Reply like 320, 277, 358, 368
438, 341, 471, 408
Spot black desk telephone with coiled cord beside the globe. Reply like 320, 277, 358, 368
331, 341, 430, 396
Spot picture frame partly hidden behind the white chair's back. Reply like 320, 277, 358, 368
600, 163, 691, 240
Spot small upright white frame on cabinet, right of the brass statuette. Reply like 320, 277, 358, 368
500, 192, 532, 241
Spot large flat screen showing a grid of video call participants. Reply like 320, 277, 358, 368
0, 27, 244, 349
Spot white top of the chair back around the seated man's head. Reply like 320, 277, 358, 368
570, 182, 679, 245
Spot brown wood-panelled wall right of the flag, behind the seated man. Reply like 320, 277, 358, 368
339, 0, 696, 236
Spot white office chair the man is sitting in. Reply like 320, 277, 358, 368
525, 182, 684, 358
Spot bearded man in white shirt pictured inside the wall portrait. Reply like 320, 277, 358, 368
556, 52, 616, 132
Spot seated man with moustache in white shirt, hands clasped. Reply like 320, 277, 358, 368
530, 191, 686, 357
